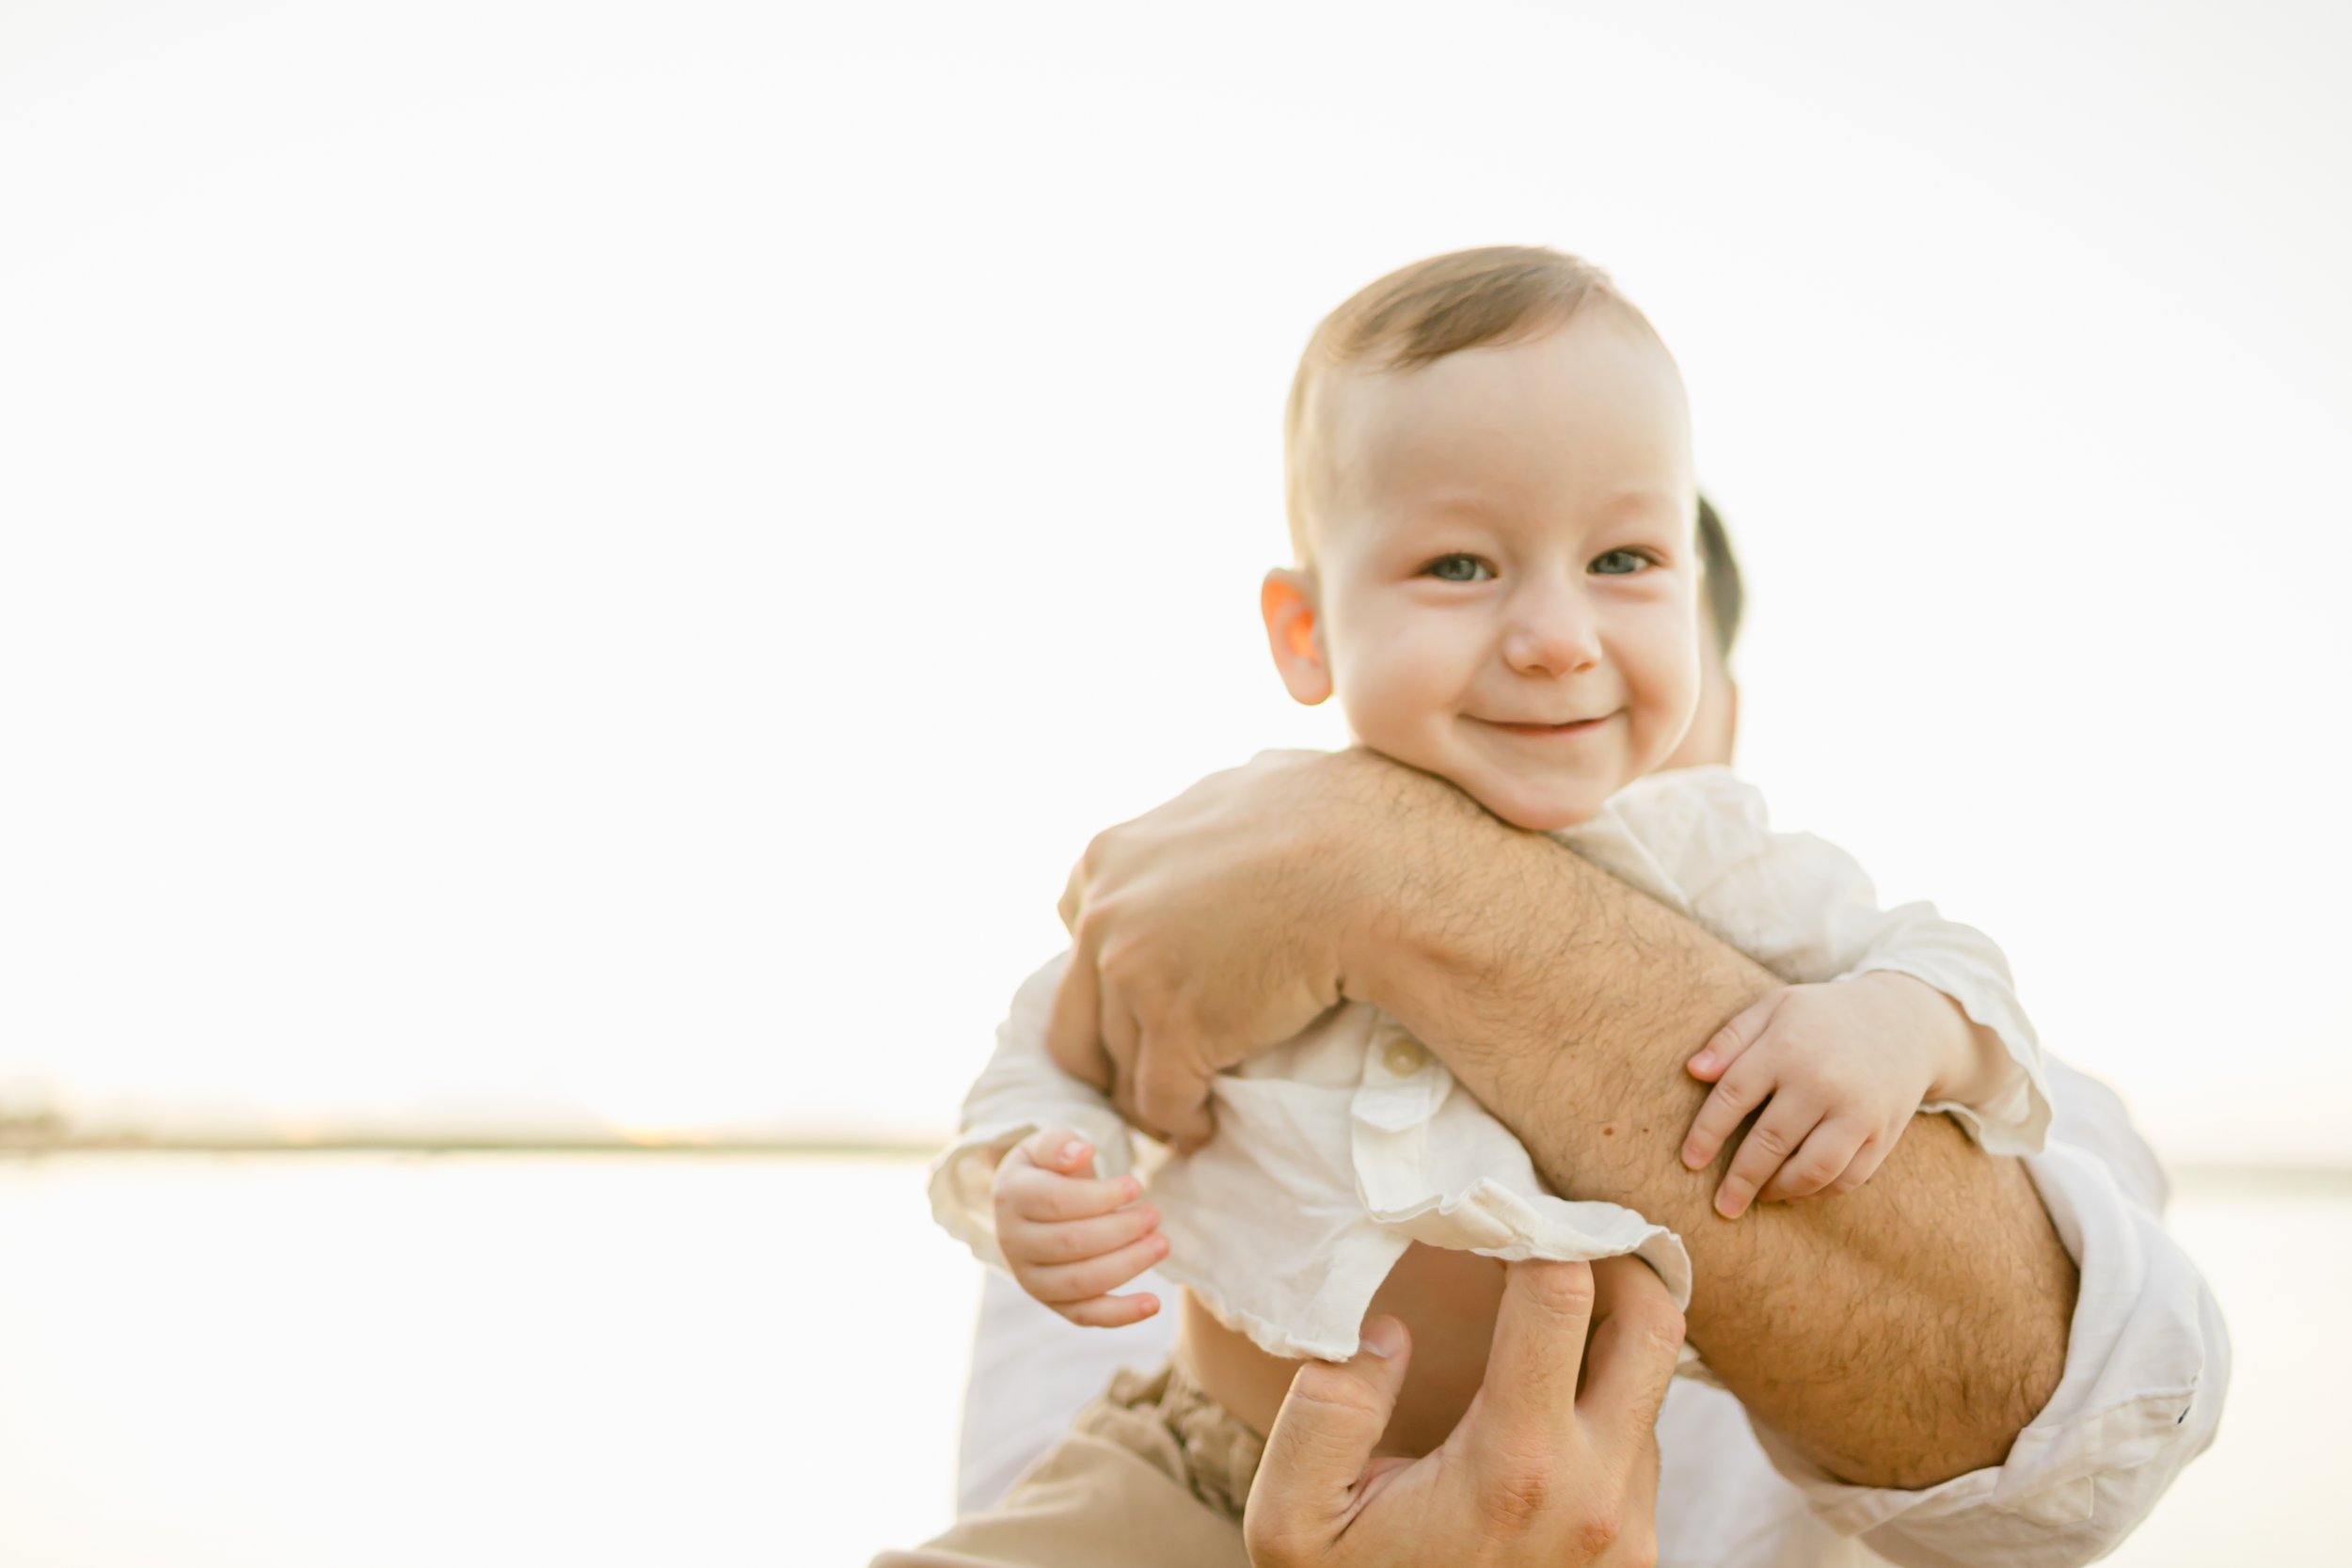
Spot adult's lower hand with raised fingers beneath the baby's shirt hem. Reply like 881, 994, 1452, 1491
1242, 1258, 1682, 1568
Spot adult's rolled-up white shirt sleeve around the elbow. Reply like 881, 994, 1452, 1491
1757, 1060, 2230, 1568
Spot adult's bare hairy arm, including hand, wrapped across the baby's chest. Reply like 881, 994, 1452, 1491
1054, 752, 2077, 1488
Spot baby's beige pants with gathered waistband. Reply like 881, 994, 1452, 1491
873, 1366, 1263, 1568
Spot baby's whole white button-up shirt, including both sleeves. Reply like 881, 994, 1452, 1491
931, 767, 2051, 1359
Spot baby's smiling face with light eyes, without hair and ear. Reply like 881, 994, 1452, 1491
1278, 308, 1698, 830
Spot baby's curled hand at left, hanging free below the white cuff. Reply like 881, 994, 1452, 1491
995, 1126, 1169, 1328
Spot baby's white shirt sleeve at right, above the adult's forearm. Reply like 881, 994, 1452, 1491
1670, 768, 2051, 1154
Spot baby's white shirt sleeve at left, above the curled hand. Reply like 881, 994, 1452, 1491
930, 952, 1134, 1270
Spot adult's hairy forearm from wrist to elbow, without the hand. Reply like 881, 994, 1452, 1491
1348, 773, 2074, 1486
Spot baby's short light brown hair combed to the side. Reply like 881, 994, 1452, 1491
1282, 245, 1656, 566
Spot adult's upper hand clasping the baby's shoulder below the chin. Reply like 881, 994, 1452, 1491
1047, 750, 1439, 1145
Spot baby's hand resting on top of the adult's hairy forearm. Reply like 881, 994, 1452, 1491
1682, 974, 1941, 1220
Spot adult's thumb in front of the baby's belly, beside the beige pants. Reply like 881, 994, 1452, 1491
1242, 1317, 1414, 1563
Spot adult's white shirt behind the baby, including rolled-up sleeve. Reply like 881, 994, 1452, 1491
958, 1058, 2230, 1568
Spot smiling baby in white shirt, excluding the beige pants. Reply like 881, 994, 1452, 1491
931, 246, 2049, 1493
